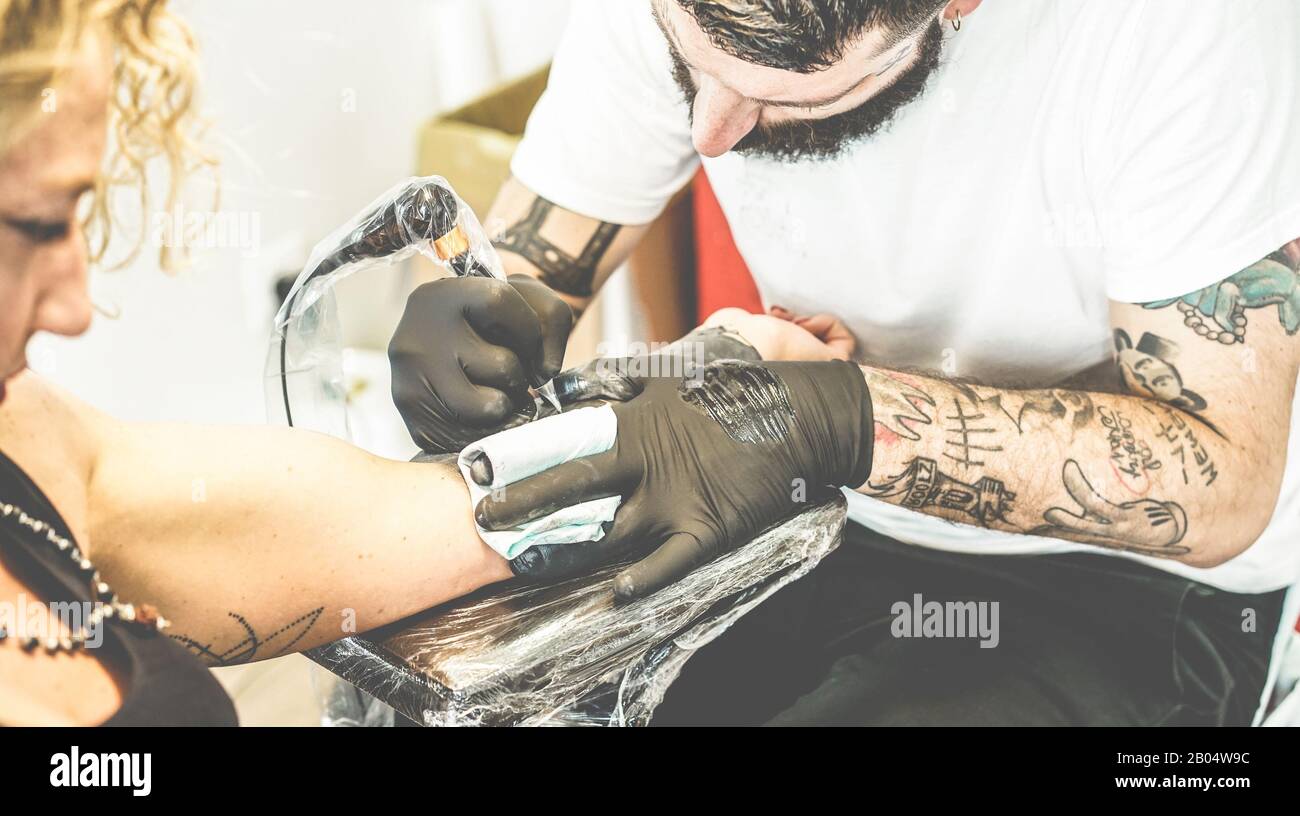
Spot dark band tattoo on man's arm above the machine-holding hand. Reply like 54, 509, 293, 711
493, 196, 623, 298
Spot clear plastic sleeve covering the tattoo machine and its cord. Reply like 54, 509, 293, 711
265, 175, 506, 438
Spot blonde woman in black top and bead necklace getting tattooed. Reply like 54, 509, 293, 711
0, 0, 824, 725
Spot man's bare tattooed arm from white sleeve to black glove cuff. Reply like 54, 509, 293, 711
858, 242, 1300, 567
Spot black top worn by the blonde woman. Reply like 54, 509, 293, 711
0, 451, 238, 725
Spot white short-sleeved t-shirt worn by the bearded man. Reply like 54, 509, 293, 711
512, 0, 1300, 593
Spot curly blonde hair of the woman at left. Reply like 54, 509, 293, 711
0, 0, 216, 270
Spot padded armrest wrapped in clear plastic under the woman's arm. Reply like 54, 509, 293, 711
312, 492, 845, 726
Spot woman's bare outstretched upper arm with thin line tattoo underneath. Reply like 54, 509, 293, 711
88, 418, 511, 665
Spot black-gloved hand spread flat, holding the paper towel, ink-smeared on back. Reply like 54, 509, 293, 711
475, 359, 872, 600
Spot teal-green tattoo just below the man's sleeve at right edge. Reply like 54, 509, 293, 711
1143, 239, 1300, 346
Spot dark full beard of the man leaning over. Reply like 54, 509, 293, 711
672, 19, 944, 161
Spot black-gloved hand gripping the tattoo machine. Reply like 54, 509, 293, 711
389, 274, 573, 452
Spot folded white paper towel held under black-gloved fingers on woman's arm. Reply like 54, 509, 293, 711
456, 405, 623, 559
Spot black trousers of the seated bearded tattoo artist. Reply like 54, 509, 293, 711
653, 524, 1284, 725
